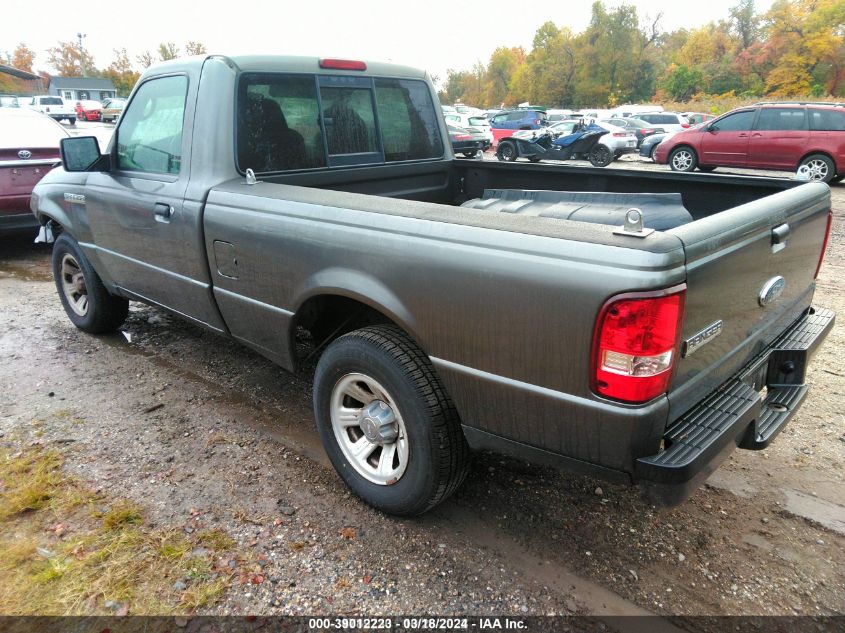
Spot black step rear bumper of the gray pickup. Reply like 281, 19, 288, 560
634, 308, 836, 505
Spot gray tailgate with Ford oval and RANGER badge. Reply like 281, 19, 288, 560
667, 183, 830, 422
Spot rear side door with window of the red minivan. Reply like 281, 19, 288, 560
748, 108, 810, 169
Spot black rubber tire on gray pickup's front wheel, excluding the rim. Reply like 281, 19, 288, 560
51, 233, 129, 334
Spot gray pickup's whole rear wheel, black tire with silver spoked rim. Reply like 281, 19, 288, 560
314, 325, 469, 516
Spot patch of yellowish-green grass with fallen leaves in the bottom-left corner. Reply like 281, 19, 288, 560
0, 447, 244, 615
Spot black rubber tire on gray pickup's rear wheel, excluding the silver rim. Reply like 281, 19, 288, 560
314, 325, 470, 516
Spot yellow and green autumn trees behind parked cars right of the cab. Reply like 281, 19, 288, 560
440, 0, 845, 107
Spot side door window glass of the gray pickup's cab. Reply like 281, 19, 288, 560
116, 75, 188, 174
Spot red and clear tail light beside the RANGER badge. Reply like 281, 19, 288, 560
593, 284, 686, 402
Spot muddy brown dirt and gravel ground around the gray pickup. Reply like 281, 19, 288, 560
0, 162, 845, 615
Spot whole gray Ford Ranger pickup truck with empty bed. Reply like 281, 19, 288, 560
32, 55, 834, 515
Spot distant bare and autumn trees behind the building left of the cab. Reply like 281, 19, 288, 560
0, 41, 207, 97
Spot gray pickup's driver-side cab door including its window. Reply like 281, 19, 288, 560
86, 71, 223, 329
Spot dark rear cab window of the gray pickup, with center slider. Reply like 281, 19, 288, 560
236, 73, 443, 173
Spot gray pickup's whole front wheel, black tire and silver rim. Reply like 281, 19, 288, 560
52, 233, 129, 334
